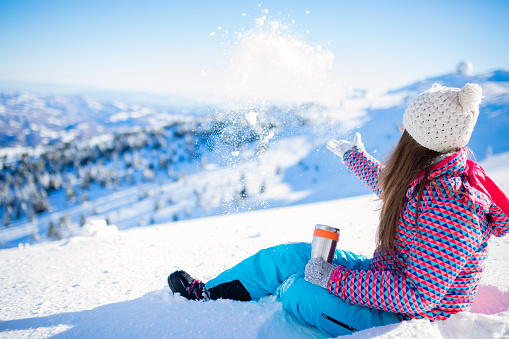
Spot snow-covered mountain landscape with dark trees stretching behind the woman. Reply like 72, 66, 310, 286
0, 71, 509, 247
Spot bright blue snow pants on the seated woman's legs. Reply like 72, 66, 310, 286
206, 243, 400, 336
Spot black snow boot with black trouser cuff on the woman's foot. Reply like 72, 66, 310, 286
168, 271, 251, 301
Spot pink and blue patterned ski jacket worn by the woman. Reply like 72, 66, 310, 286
329, 148, 509, 320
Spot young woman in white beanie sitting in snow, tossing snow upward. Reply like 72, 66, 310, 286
168, 84, 509, 336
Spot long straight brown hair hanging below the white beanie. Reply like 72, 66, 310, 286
377, 131, 442, 253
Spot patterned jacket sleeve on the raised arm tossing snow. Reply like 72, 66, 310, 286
343, 147, 383, 197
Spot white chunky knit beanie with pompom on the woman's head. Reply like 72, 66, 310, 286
403, 83, 482, 153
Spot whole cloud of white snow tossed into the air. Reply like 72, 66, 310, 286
204, 9, 341, 213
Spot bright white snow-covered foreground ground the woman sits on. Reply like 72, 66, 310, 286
0, 153, 509, 339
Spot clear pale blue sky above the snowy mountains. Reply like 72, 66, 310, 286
0, 0, 509, 103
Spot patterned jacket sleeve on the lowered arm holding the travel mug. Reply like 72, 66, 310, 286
329, 194, 481, 318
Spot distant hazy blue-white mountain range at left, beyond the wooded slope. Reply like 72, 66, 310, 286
0, 89, 200, 147
